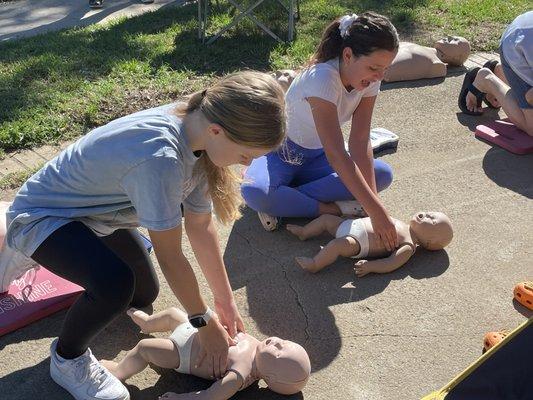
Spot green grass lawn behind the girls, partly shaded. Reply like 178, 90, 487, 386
0, 0, 529, 155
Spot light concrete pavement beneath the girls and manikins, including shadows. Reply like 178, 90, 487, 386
0, 1, 533, 400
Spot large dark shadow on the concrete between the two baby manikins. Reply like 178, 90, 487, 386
224, 208, 450, 372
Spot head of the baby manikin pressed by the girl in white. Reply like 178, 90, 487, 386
409, 211, 453, 250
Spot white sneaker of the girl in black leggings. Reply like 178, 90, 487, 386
50, 339, 130, 400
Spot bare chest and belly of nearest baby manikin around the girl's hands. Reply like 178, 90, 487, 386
191, 328, 260, 387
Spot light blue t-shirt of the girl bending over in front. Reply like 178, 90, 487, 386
6, 104, 211, 257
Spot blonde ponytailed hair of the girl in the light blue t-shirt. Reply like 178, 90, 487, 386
176, 71, 286, 224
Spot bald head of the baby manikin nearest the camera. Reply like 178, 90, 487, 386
255, 337, 311, 395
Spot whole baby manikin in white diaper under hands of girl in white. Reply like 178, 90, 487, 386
287, 211, 453, 277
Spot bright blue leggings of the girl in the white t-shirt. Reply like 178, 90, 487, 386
241, 140, 392, 218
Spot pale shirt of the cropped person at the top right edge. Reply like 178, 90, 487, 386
500, 11, 533, 86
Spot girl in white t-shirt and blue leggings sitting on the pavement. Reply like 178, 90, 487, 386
241, 12, 399, 250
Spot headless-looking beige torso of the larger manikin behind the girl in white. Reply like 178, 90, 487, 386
383, 42, 447, 82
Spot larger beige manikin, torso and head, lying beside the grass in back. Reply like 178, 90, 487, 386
383, 36, 470, 82
